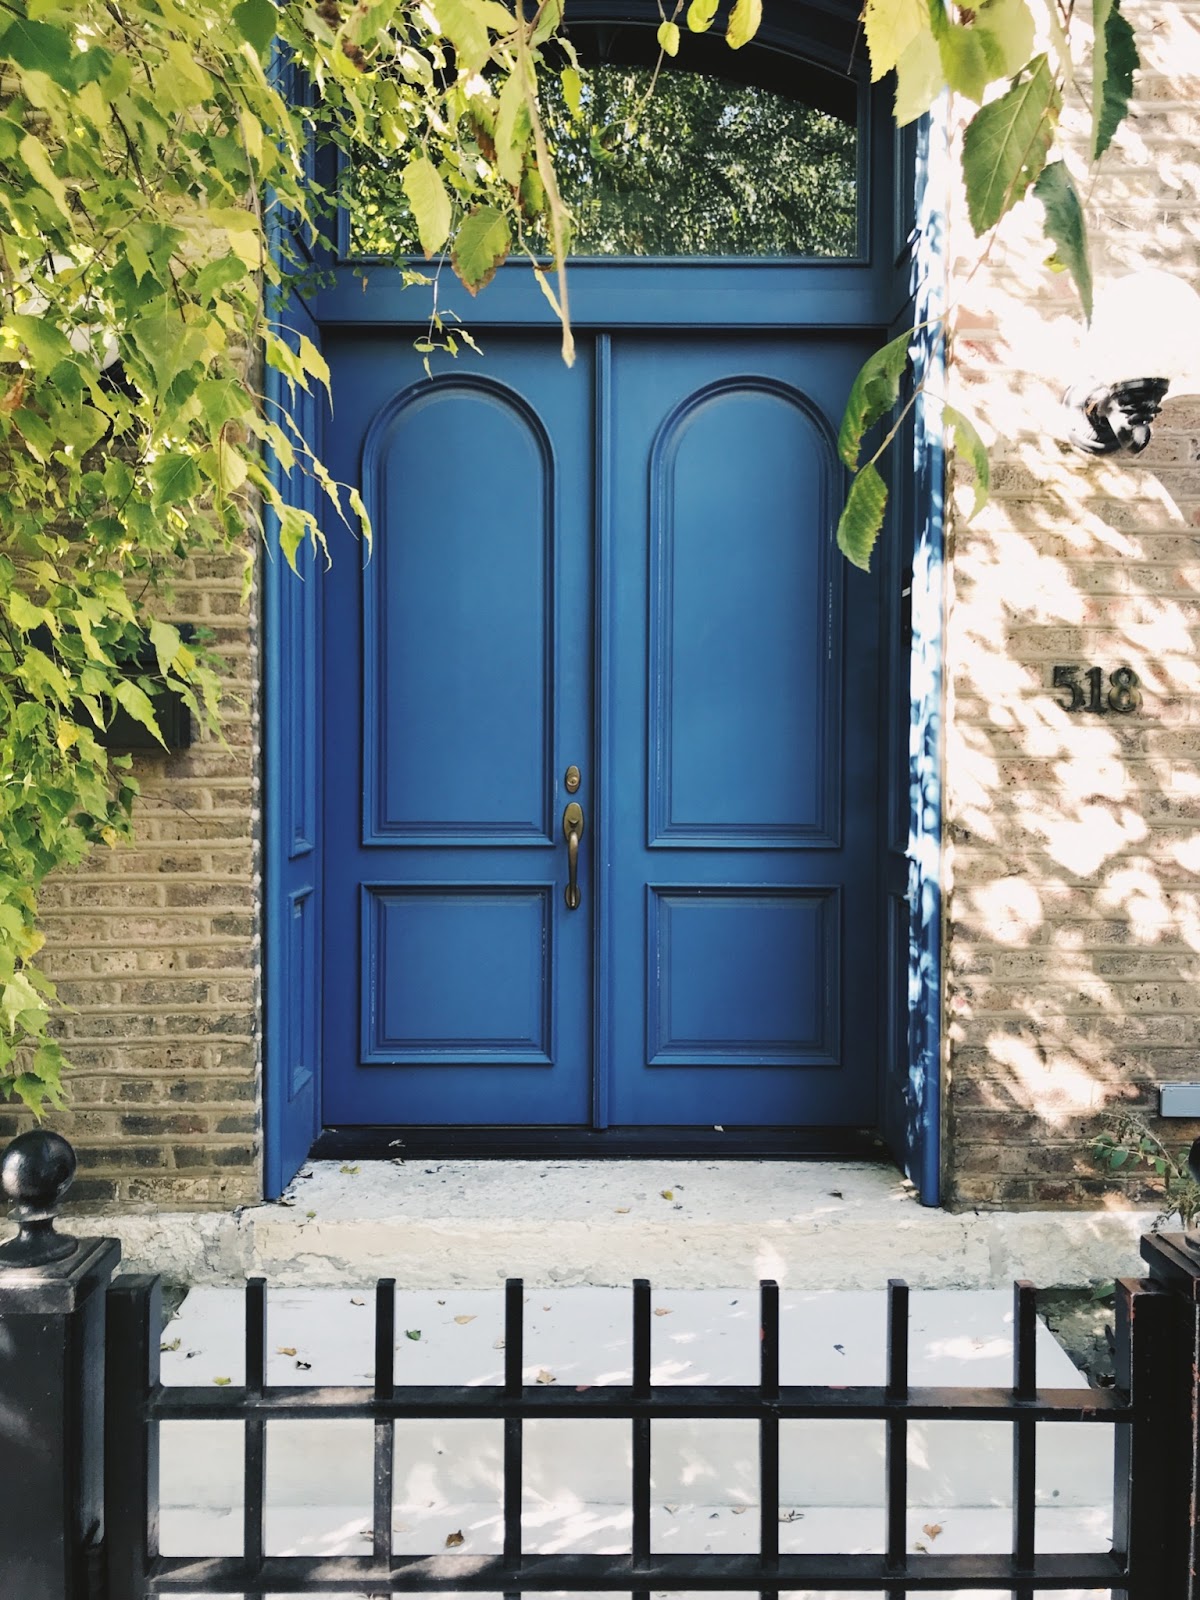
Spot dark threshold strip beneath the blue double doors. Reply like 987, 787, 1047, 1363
310, 1125, 891, 1162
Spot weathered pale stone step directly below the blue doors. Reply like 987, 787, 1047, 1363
58, 1158, 1152, 1290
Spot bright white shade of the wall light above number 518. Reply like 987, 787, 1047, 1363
1082, 269, 1200, 392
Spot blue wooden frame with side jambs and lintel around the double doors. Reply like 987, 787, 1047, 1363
262, 0, 944, 1205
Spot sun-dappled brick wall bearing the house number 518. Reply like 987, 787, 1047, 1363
946, 0, 1200, 1206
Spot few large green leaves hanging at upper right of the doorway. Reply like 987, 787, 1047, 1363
837, 0, 1138, 570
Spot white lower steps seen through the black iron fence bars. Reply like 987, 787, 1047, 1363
162, 1286, 1112, 1600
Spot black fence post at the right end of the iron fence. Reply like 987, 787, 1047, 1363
1141, 1234, 1200, 1600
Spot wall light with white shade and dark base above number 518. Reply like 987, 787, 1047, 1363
1062, 270, 1200, 456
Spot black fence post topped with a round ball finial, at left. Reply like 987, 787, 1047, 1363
0, 1128, 120, 1600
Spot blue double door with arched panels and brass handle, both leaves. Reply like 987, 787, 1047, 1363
323, 330, 882, 1130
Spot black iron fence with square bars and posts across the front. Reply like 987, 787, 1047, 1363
0, 1134, 1200, 1600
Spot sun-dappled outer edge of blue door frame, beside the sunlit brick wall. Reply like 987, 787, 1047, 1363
909, 102, 949, 1205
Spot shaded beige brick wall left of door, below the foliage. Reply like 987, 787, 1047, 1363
0, 558, 261, 1208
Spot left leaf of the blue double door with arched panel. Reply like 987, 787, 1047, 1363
323, 333, 592, 1125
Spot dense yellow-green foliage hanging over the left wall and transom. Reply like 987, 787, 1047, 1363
0, 0, 649, 1110
